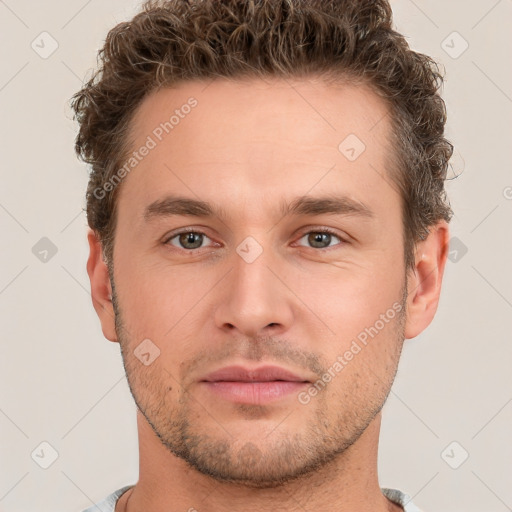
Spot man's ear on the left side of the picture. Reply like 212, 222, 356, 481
87, 230, 118, 341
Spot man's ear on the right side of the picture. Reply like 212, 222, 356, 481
405, 220, 450, 339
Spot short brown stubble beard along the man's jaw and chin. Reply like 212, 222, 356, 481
111, 272, 406, 489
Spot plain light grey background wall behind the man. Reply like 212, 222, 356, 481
0, 0, 512, 512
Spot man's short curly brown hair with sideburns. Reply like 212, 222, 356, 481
71, 0, 453, 269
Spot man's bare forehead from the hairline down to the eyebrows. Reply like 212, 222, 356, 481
119, 78, 395, 221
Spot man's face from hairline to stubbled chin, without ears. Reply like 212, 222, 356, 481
95, 79, 416, 487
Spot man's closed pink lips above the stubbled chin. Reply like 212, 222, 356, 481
200, 366, 311, 405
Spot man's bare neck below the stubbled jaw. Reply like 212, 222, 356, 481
116, 412, 402, 512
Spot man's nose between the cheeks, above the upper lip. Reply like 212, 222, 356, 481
215, 244, 293, 337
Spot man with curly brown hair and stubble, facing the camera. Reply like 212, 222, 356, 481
73, 0, 452, 512
